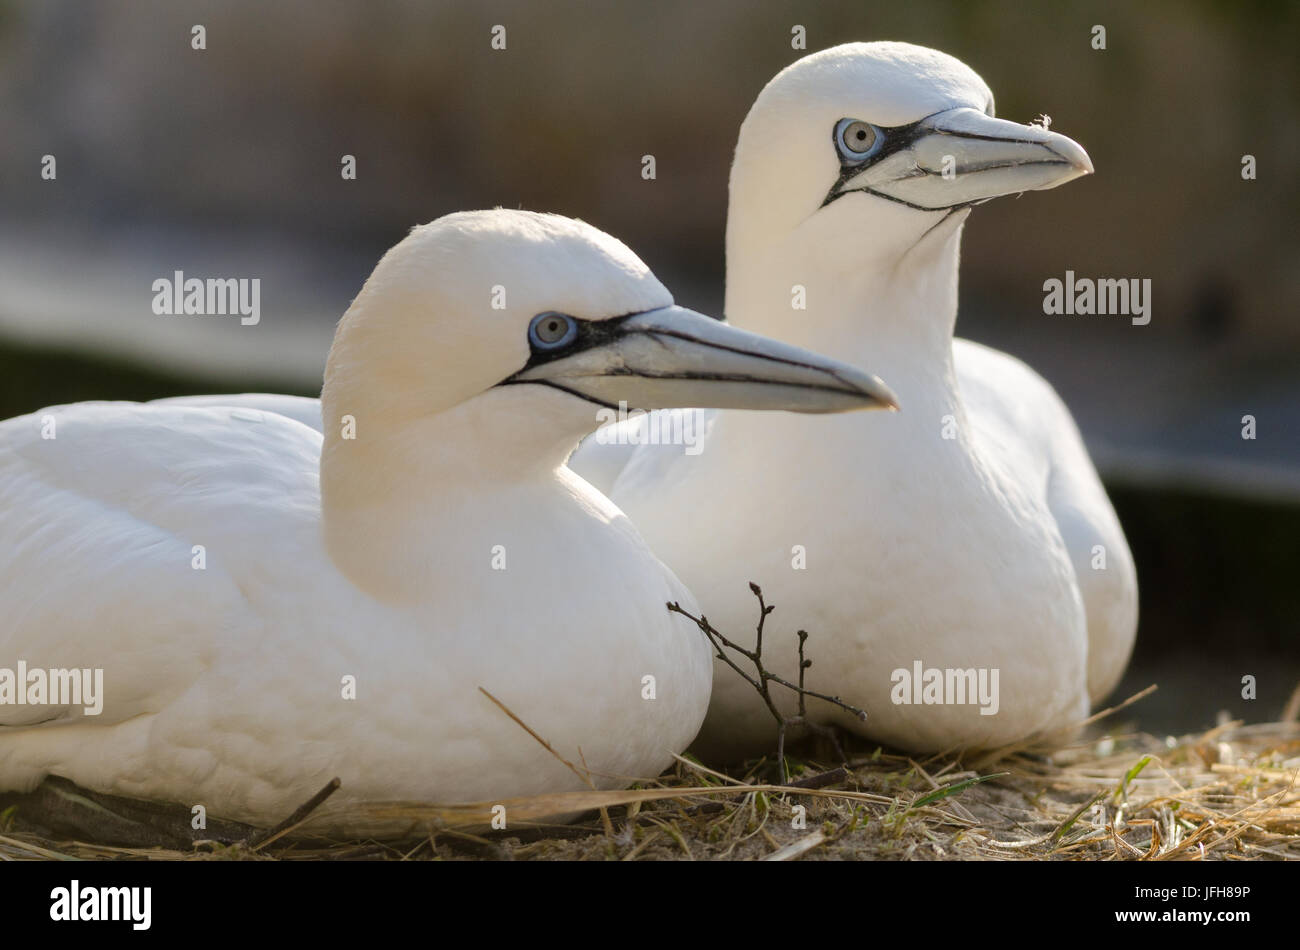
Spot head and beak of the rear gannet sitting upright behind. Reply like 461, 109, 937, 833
728, 43, 1092, 269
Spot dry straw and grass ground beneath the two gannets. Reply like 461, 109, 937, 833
0, 706, 1300, 860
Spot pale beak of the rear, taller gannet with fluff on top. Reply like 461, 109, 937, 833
827, 108, 1092, 211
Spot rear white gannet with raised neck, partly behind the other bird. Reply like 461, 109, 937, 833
571, 43, 1138, 755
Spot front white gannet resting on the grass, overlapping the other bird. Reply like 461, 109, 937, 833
0, 211, 891, 823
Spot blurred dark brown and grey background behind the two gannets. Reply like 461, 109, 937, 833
0, 0, 1300, 732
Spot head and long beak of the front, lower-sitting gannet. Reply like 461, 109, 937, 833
322, 209, 894, 443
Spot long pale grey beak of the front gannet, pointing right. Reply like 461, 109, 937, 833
507, 307, 898, 412
